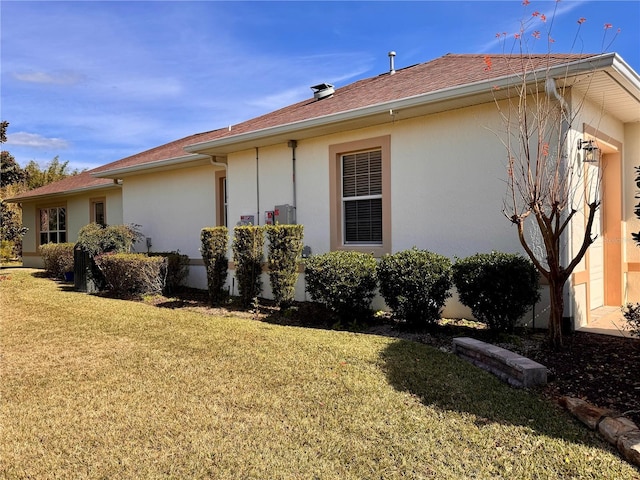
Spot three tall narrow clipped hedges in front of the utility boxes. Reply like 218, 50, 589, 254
200, 225, 304, 307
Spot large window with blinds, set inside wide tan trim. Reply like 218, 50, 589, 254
342, 150, 383, 245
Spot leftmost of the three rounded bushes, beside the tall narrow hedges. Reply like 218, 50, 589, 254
304, 251, 377, 324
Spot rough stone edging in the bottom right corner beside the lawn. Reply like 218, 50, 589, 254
559, 397, 640, 467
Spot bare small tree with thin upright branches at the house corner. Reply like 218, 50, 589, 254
485, 2, 608, 348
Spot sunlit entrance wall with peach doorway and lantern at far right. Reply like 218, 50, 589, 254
567, 92, 640, 327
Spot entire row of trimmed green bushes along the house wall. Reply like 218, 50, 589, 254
41, 224, 539, 331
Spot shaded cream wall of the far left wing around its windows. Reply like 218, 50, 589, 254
22, 187, 122, 268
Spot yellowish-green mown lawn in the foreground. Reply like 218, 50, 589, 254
0, 269, 638, 479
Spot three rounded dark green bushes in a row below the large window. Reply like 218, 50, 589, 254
305, 248, 539, 331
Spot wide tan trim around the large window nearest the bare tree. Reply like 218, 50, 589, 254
329, 135, 391, 257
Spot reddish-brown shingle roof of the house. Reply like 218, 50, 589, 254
7, 54, 596, 199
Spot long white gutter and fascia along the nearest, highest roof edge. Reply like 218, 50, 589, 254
185, 53, 619, 153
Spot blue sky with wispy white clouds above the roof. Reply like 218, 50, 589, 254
0, 0, 640, 168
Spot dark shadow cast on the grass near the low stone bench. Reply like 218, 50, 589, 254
381, 340, 604, 445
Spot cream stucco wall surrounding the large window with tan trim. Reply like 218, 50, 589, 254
228, 104, 546, 326
